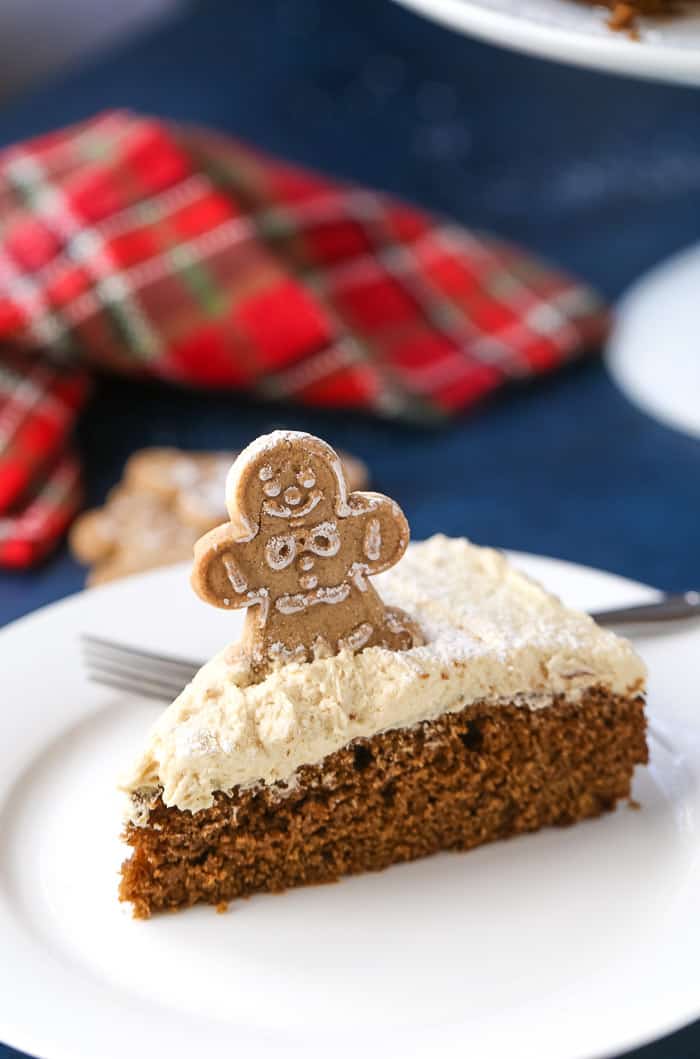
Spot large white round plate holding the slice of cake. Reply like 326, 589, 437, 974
0, 556, 700, 1059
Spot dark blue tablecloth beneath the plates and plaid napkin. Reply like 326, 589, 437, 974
0, 0, 700, 1059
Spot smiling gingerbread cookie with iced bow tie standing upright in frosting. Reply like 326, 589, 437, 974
193, 430, 423, 674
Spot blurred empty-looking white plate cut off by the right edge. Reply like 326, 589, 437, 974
606, 245, 700, 438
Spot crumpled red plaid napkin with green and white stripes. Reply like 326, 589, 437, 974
0, 112, 607, 566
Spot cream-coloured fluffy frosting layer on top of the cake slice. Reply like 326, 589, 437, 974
123, 535, 646, 820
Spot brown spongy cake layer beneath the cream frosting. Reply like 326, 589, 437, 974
120, 686, 647, 918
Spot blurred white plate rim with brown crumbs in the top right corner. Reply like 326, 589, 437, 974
398, 0, 700, 85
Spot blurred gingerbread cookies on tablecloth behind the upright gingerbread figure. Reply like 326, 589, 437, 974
70, 448, 369, 585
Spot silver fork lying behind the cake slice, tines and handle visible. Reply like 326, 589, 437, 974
82, 592, 700, 700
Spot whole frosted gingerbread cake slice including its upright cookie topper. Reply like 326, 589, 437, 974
120, 432, 647, 917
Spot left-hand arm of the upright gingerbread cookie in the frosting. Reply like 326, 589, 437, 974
192, 522, 255, 610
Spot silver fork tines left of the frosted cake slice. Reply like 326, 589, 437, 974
82, 634, 201, 700
